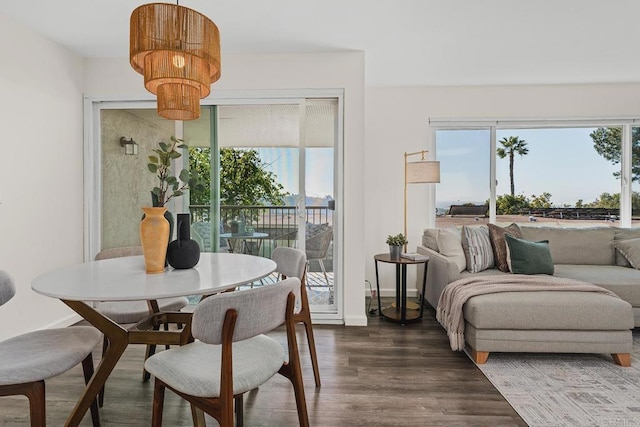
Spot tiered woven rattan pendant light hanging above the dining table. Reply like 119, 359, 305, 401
129, 3, 220, 120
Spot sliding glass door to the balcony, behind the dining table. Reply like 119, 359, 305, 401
92, 97, 342, 321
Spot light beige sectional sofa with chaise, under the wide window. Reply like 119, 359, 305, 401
417, 224, 640, 365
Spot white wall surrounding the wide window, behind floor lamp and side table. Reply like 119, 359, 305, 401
364, 83, 640, 295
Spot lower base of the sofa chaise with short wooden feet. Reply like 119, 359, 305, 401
464, 322, 633, 366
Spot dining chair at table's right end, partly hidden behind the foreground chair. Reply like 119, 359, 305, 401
271, 246, 320, 387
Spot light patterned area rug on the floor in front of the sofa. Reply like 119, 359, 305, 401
470, 329, 640, 427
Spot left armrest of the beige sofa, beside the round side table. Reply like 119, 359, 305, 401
416, 246, 462, 309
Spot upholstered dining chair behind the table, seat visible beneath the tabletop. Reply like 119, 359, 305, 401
95, 246, 189, 396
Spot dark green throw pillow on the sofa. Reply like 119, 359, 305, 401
504, 234, 553, 274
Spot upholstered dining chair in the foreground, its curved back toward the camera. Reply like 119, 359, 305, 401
145, 277, 309, 427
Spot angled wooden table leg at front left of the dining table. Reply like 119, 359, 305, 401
62, 300, 129, 427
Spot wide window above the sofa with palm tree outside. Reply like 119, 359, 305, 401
431, 119, 640, 227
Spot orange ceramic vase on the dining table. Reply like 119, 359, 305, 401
140, 207, 169, 273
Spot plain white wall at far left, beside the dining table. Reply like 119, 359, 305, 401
0, 16, 83, 340
